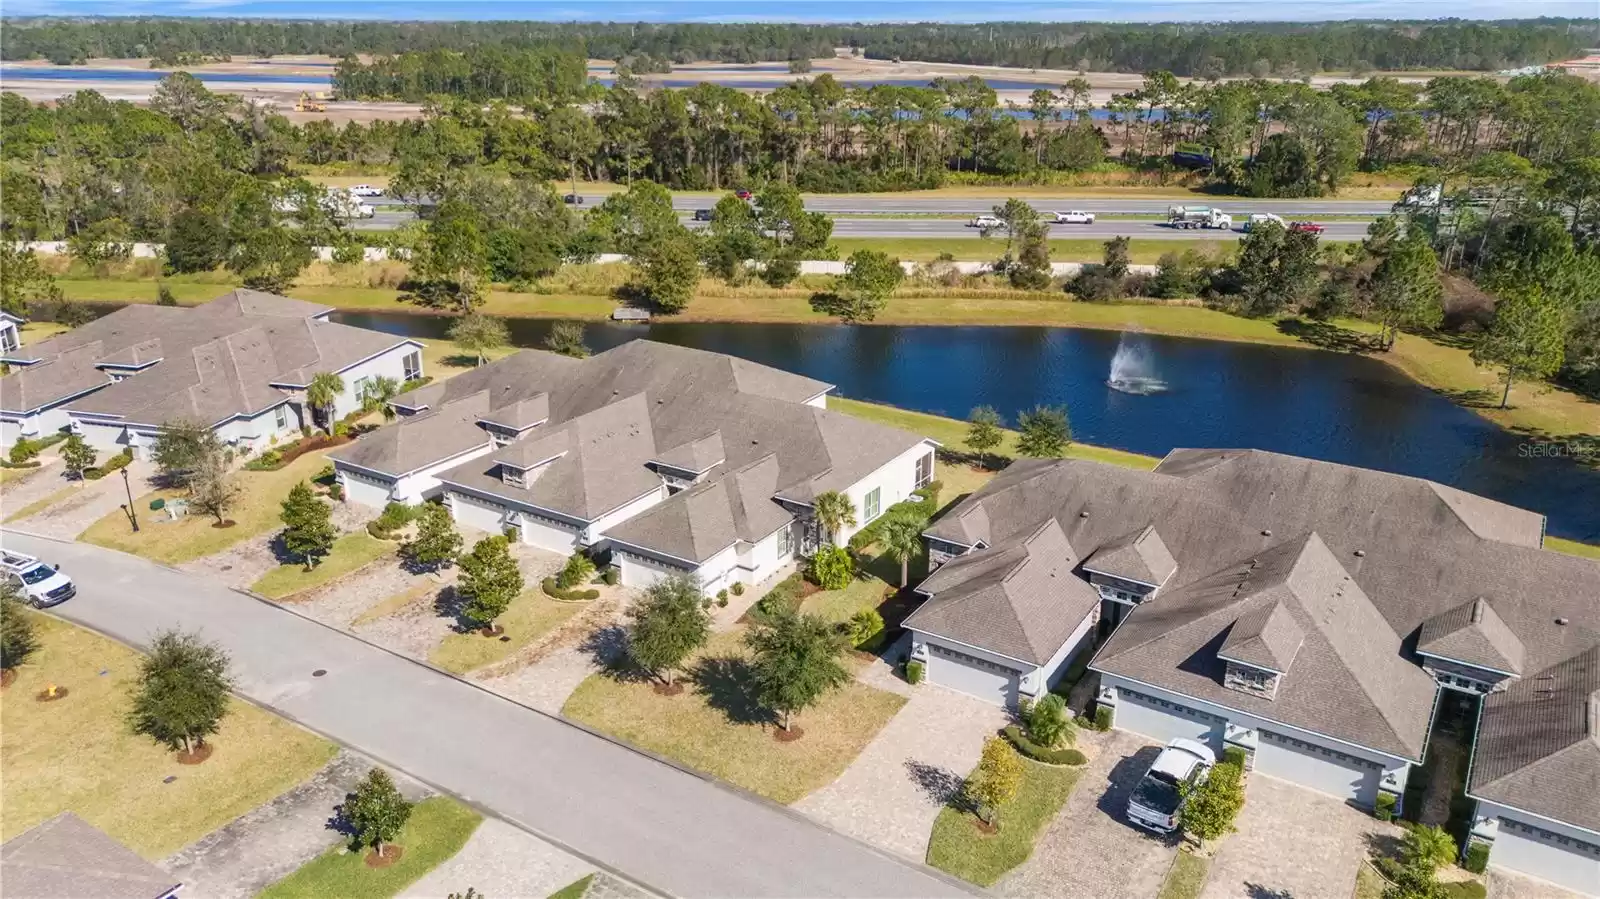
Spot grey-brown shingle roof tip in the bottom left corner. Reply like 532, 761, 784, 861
0, 811, 179, 899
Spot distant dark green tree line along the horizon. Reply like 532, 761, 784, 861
0, 18, 1600, 77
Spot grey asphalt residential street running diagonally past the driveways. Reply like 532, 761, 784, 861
5, 531, 971, 897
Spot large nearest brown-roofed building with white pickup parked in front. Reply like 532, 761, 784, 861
906, 450, 1600, 894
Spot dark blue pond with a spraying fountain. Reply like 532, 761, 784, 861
334, 312, 1600, 542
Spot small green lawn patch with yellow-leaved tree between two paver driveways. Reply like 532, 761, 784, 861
928, 758, 1080, 886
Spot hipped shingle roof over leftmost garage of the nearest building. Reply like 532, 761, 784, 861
904, 518, 1099, 665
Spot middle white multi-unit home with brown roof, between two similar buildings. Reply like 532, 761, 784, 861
330, 341, 936, 592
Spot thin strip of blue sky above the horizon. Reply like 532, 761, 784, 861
12, 0, 1600, 22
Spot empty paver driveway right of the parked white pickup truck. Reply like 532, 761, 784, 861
1200, 774, 1400, 899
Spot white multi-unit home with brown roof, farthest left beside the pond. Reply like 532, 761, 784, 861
0, 290, 422, 456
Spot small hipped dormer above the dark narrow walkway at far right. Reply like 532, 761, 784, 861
1416, 597, 1523, 693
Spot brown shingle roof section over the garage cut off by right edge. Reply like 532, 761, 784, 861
1467, 643, 1600, 833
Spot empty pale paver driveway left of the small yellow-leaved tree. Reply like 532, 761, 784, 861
795, 685, 1006, 862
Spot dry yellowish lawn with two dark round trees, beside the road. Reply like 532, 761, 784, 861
562, 630, 906, 805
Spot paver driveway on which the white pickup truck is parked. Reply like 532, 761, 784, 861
997, 731, 1171, 899
